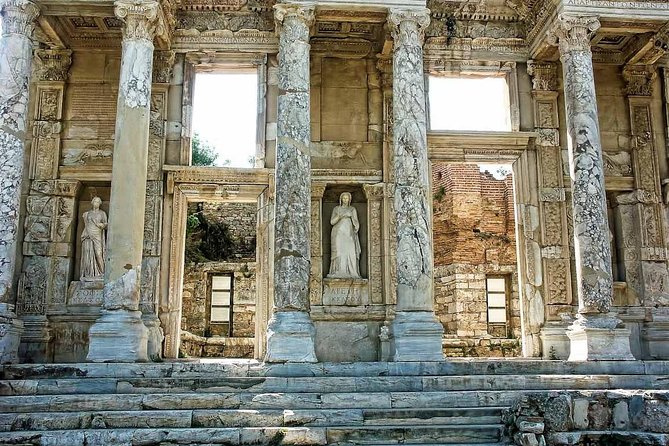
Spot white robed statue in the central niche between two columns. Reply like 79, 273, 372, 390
328, 192, 360, 279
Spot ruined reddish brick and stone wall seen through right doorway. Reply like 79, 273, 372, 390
432, 163, 520, 356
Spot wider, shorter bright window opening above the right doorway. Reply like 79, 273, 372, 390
429, 76, 512, 132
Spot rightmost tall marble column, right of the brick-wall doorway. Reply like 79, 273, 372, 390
550, 14, 634, 361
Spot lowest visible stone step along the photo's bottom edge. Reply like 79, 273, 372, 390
0, 425, 503, 446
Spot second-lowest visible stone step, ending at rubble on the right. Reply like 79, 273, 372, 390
0, 407, 504, 431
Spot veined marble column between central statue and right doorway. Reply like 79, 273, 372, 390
388, 9, 443, 361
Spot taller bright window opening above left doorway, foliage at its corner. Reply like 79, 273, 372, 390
191, 68, 258, 167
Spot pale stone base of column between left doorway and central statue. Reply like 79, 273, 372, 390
265, 311, 318, 362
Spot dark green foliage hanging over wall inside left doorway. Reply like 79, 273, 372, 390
185, 207, 235, 263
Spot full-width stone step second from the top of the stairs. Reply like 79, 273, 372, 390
0, 375, 669, 396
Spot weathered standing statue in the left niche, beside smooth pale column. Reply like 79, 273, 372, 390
80, 197, 107, 281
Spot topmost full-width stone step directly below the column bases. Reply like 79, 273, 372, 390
0, 359, 669, 379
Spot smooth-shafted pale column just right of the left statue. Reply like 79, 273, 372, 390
88, 0, 159, 362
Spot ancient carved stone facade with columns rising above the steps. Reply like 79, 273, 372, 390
0, 0, 669, 362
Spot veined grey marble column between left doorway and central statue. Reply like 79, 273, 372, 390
265, 4, 316, 362
